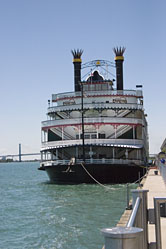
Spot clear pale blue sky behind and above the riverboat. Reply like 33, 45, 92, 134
0, 0, 166, 155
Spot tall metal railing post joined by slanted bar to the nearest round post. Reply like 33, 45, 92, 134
131, 189, 149, 249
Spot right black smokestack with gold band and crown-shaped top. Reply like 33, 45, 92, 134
113, 47, 125, 90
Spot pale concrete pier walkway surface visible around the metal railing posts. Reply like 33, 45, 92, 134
111, 165, 166, 249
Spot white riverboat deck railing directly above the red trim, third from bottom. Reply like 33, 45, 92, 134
42, 117, 143, 127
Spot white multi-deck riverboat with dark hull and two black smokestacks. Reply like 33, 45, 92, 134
40, 48, 148, 184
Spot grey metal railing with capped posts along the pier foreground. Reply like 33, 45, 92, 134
102, 183, 166, 249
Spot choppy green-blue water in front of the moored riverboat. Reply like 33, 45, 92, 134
0, 162, 134, 249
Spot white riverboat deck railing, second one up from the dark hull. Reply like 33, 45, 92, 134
41, 139, 143, 151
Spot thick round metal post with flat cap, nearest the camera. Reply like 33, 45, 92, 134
101, 227, 143, 249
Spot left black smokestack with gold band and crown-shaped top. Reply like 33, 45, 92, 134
71, 49, 83, 92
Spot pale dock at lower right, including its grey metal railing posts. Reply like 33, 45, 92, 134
102, 163, 166, 249
